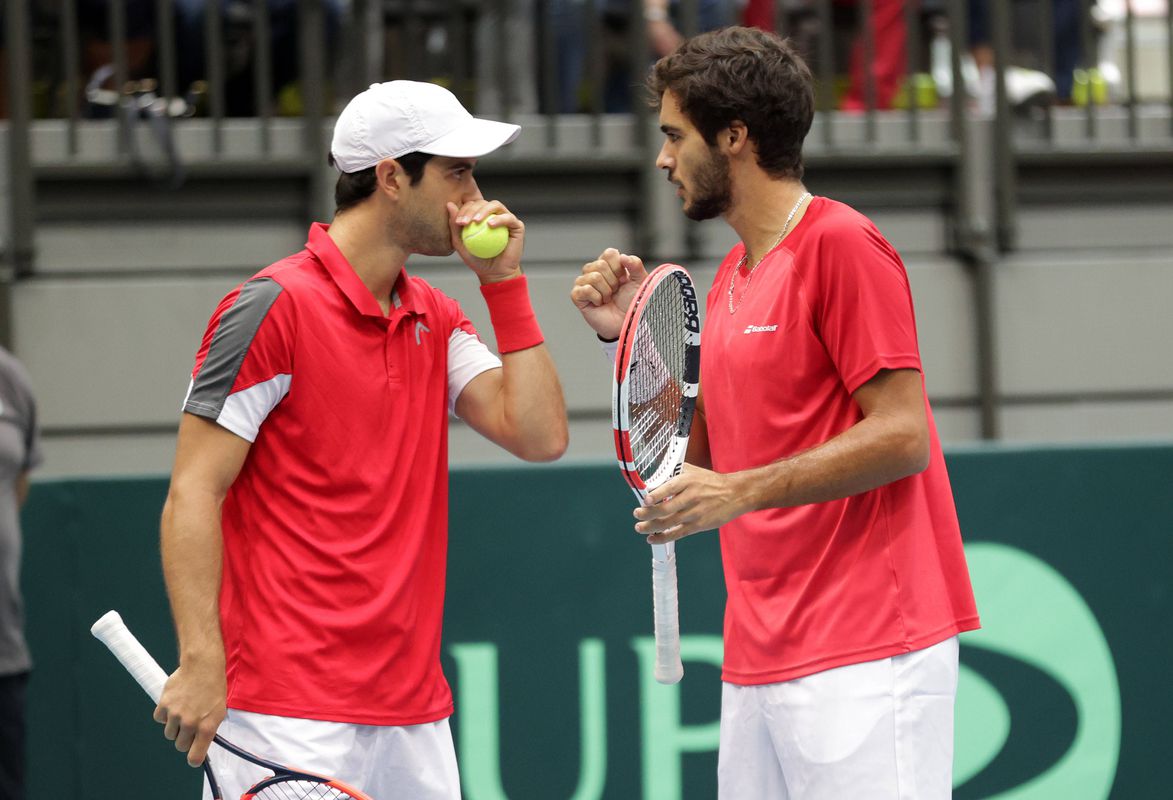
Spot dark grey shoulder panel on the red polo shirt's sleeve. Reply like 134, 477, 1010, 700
183, 278, 284, 419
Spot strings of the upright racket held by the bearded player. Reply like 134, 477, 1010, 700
628, 280, 686, 475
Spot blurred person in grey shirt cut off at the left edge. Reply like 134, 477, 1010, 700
0, 347, 41, 800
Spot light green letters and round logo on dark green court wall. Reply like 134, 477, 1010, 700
449, 543, 1120, 800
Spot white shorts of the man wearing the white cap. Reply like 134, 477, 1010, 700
204, 709, 460, 800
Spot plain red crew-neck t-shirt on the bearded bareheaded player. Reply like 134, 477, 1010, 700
700, 197, 978, 685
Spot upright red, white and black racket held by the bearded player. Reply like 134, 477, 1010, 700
611, 264, 700, 684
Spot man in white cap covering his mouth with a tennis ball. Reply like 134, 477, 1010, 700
155, 81, 567, 800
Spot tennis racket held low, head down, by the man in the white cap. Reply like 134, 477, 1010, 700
89, 611, 371, 800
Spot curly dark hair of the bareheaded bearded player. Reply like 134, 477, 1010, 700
647, 27, 814, 178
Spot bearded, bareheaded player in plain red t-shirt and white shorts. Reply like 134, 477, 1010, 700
571, 28, 978, 800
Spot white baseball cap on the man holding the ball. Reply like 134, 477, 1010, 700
330, 81, 521, 172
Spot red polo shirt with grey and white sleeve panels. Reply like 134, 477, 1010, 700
184, 225, 493, 725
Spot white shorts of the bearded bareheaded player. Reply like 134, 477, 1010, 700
717, 636, 957, 800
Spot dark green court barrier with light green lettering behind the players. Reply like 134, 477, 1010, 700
23, 443, 1173, 800
